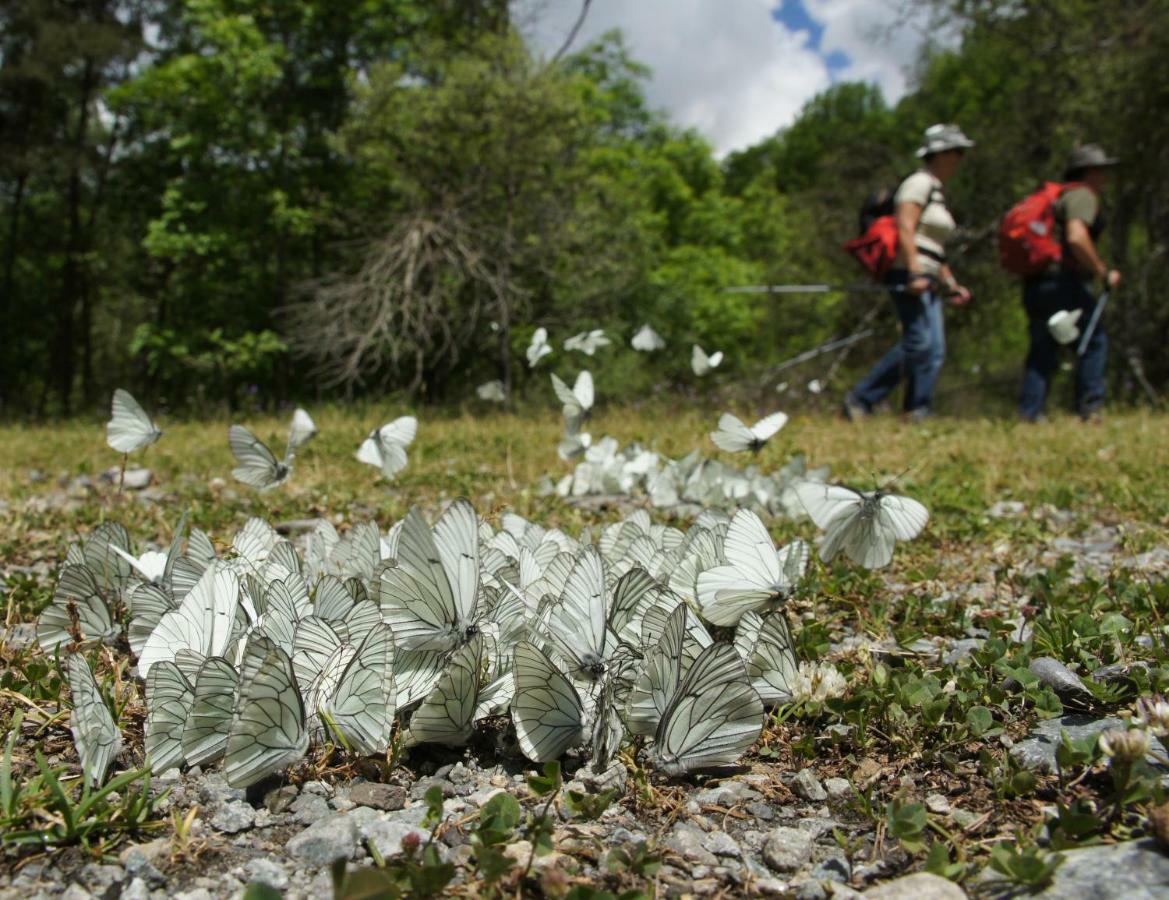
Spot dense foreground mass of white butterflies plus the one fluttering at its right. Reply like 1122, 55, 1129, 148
45, 482, 927, 787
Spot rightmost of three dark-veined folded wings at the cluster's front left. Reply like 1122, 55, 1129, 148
223, 636, 309, 788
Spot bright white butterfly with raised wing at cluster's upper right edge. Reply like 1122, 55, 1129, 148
697, 510, 809, 625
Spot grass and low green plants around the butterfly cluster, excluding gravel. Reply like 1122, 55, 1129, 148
0, 404, 1169, 884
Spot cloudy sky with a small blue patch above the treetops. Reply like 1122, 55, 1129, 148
513, 0, 922, 155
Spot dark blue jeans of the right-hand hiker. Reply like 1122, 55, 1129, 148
1019, 272, 1108, 422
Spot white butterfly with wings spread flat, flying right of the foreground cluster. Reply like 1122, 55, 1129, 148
795, 482, 929, 569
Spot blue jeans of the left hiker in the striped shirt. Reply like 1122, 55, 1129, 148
852, 270, 946, 415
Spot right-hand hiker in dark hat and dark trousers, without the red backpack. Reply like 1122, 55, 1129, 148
1019, 144, 1120, 422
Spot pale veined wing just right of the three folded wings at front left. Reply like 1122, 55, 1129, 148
324, 621, 397, 756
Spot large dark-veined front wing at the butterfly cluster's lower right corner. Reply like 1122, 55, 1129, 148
651, 644, 763, 775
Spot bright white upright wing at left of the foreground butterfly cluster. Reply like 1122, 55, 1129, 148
138, 563, 240, 678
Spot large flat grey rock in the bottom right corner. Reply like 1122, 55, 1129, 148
1035, 839, 1169, 900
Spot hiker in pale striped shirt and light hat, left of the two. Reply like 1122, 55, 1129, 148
844, 125, 974, 421
